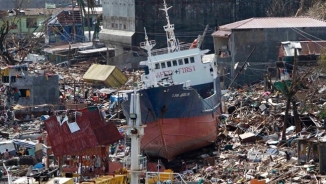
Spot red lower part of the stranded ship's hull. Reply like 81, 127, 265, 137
141, 113, 218, 160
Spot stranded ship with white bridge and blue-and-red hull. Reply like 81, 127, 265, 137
121, 0, 221, 160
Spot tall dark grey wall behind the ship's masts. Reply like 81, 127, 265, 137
133, 0, 236, 51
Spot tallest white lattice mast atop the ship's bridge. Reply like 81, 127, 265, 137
160, 0, 179, 53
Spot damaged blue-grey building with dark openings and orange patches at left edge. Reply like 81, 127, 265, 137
1, 65, 59, 107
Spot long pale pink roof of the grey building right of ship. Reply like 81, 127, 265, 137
219, 17, 326, 30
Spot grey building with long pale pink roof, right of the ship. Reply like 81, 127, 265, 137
212, 17, 326, 84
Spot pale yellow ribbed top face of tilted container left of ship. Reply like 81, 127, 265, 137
83, 64, 115, 82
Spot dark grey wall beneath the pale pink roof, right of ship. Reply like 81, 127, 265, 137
230, 27, 326, 84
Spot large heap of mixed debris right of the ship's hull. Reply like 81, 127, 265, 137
171, 84, 326, 183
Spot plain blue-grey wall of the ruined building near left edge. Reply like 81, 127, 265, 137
12, 76, 59, 106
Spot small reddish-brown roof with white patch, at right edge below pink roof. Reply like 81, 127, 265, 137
279, 41, 326, 57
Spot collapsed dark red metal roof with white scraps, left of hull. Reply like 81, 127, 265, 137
44, 107, 122, 156
